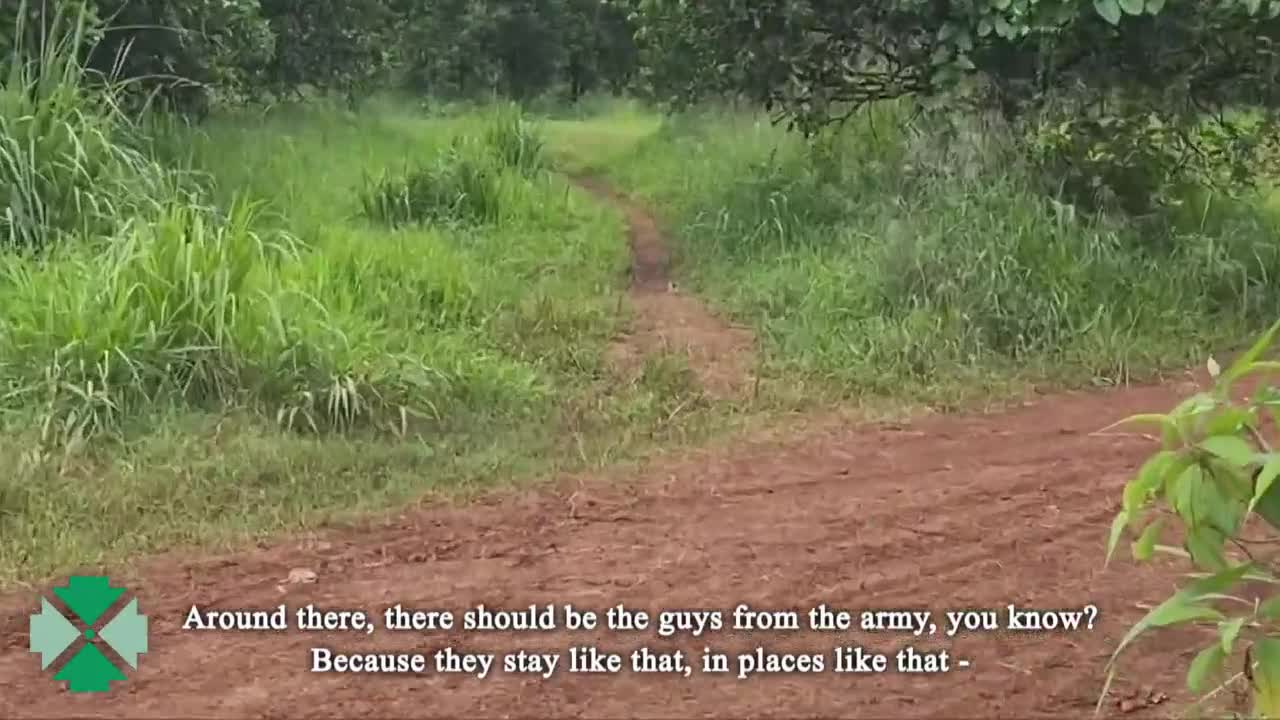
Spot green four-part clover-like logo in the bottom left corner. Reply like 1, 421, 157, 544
31, 575, 147, 693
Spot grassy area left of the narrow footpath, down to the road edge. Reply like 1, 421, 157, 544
0, 92, 737, 584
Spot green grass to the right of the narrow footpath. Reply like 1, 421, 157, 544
566, 101, 1280, 404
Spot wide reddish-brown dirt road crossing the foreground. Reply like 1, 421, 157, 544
0, 180, 1198, 719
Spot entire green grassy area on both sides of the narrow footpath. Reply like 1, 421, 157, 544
0, 44, 1280, 585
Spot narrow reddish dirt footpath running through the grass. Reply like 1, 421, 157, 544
571, 176, 755, 400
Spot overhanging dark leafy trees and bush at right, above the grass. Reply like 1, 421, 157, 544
627, 0, 1280, 214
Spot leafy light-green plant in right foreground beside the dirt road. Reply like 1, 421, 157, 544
1098, 323, 1280, 717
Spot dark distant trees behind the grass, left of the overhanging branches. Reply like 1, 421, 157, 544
0, 0, 636, 111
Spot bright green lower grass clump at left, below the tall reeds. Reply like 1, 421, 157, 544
0, 197, 483, 442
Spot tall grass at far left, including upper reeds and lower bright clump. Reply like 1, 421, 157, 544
0, 13, 527, 443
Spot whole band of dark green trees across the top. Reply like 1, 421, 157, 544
12, 0, 1280, 215
